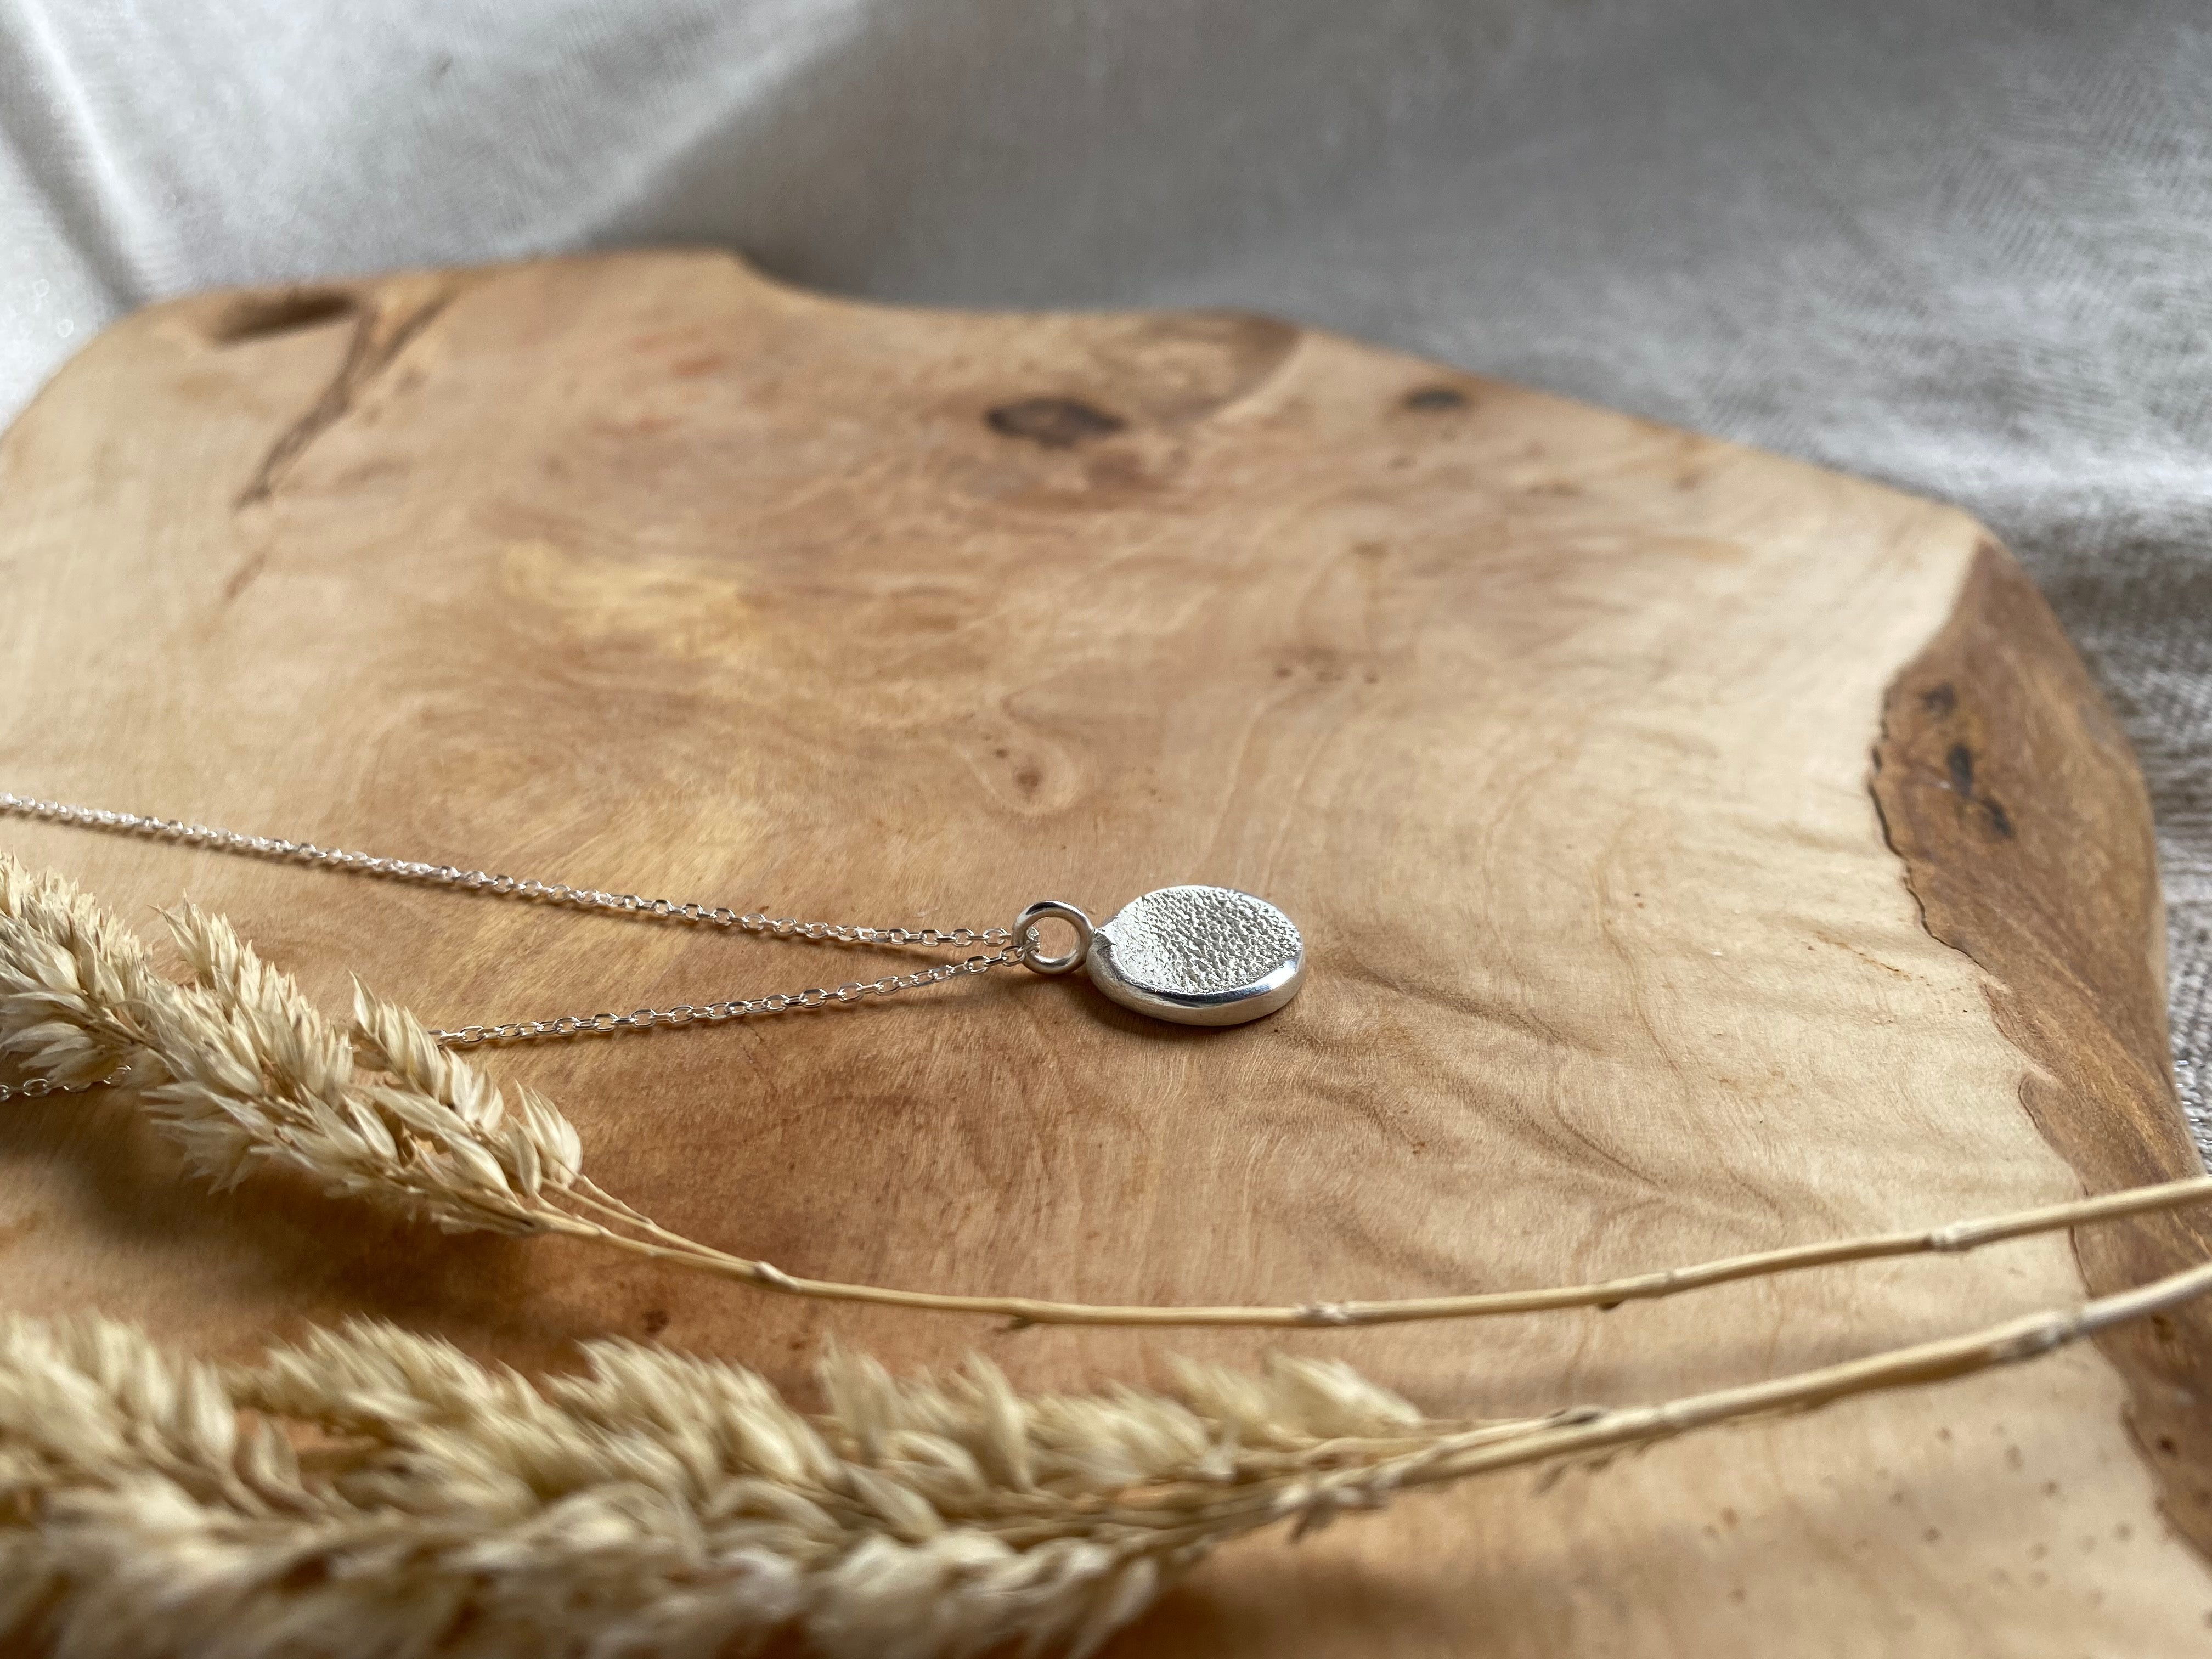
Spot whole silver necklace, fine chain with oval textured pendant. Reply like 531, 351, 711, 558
0, 794, 1305, 1053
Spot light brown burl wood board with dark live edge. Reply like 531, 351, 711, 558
0, 255, 2212, 1659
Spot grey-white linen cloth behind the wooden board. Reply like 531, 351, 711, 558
0, 0, 2212, 1144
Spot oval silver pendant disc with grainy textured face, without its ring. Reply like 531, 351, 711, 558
1086, 887, 1305, 1026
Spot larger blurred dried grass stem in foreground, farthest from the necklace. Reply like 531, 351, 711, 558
13, 1267, 2212, 1659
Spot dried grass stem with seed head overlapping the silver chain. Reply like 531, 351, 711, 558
0, 858, 2212, 1329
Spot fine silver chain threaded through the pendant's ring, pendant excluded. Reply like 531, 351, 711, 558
0, 794, 1035, 1057
